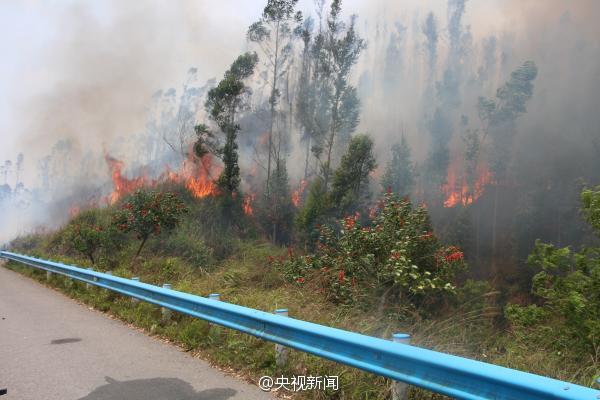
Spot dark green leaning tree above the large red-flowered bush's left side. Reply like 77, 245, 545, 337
331, 135, 377, 215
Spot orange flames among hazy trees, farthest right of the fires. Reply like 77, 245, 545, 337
442, 166, 492, 208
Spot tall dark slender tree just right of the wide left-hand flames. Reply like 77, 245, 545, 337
194, 53, 258, 197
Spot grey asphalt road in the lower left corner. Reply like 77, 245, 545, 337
0, 266, 274, 400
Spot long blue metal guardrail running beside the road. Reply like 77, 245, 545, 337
0, 251, 600, 400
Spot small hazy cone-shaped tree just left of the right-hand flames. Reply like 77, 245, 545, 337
381, 135, 415, 196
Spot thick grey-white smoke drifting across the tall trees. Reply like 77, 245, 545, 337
0, 0, 600, 288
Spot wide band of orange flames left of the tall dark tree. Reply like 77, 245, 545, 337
105, 154, 221, 204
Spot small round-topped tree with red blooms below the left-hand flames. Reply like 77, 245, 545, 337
114, 190, 188, 257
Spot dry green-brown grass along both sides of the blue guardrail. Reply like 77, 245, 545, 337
8, 233, 600, 400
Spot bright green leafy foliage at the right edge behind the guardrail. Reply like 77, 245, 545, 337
505, 189, 600, 357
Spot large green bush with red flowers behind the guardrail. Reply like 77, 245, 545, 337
277, 193, 464, 305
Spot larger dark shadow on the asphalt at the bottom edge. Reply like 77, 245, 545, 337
79, 377, 237, 400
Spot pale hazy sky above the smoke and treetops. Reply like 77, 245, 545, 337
0, 0, 600, 185
